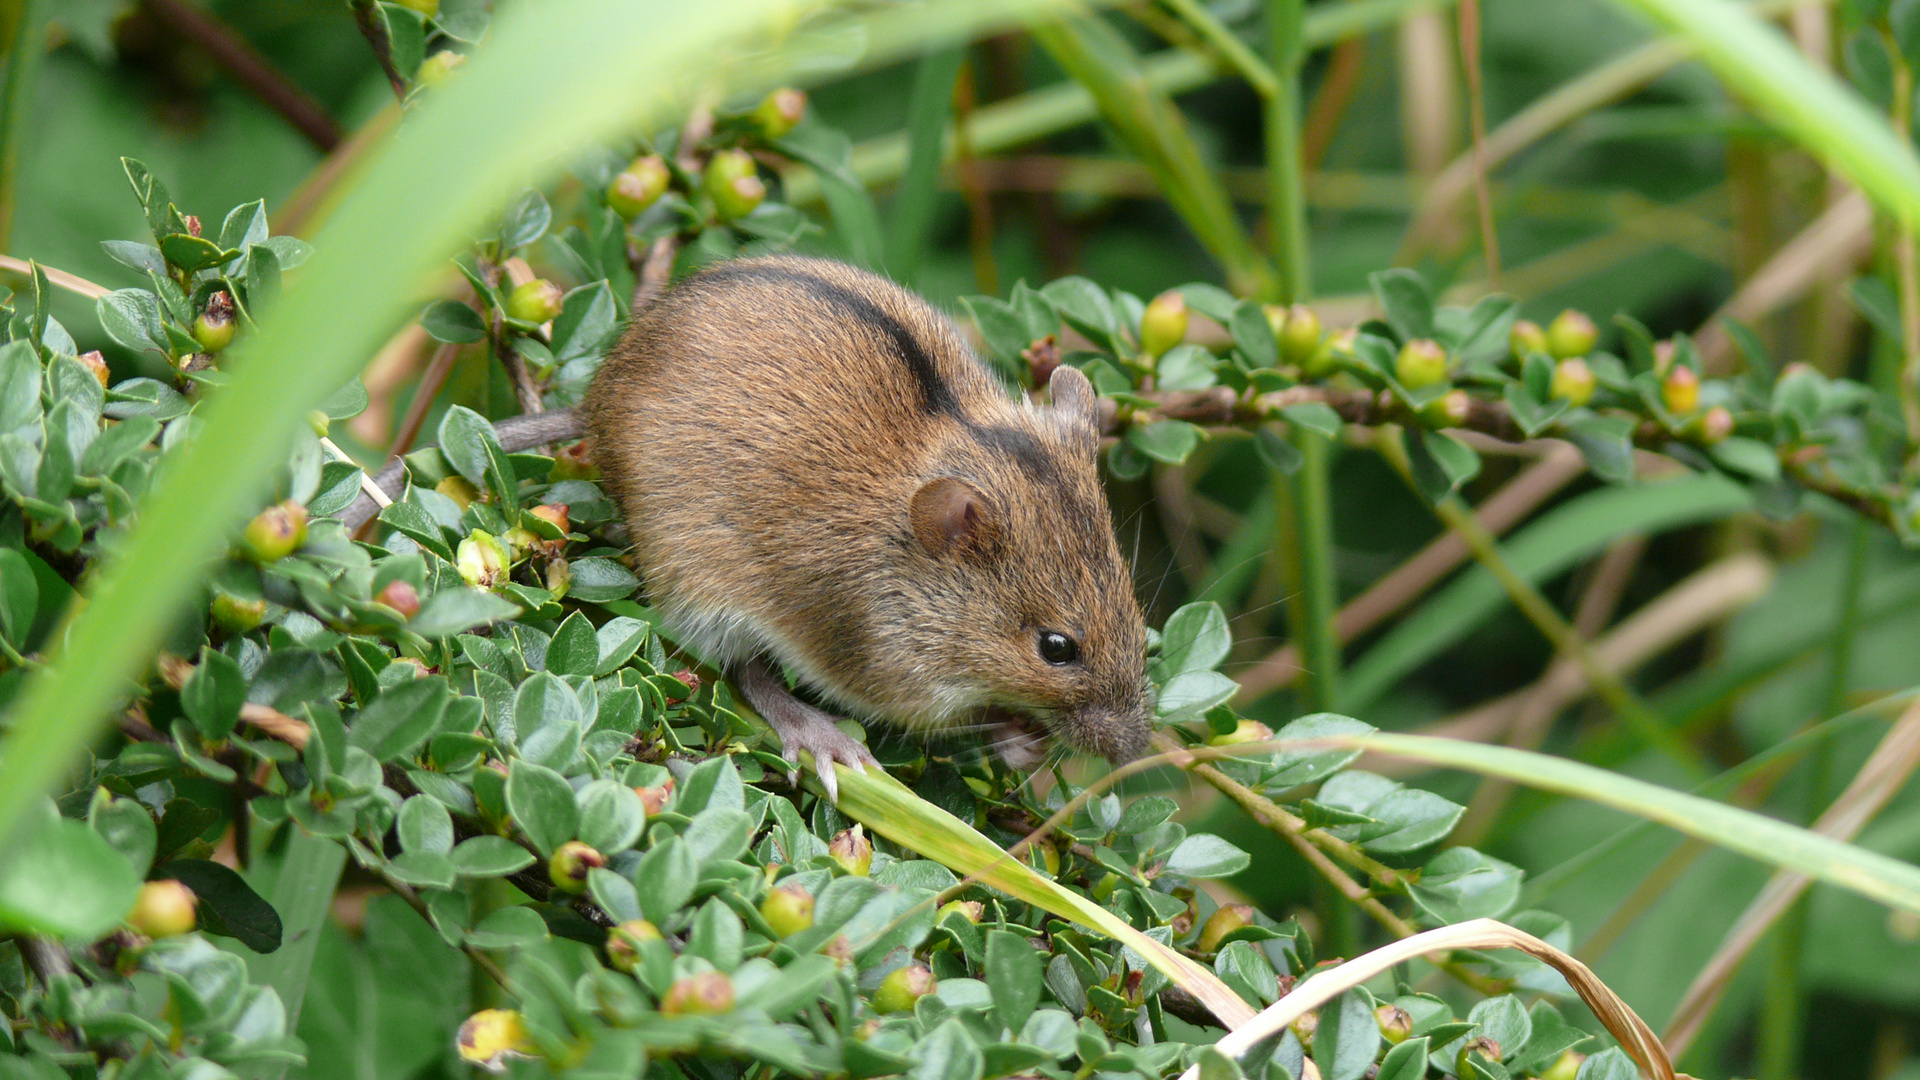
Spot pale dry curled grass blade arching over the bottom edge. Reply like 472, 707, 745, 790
1181, 919, 1690, 1080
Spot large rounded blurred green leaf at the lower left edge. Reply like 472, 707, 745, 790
0, 813, 140, 942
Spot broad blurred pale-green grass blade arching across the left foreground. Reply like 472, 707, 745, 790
0, 0, 1098, 842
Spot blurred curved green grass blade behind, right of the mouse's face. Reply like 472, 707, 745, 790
1340, 475, 1749, 713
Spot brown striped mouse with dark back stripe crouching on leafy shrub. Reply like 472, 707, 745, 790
347, 256, 1154, 801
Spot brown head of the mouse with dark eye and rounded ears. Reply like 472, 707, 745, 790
908, 365, 1152, 769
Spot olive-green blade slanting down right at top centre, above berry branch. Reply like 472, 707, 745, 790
1029, 15, 1273, 296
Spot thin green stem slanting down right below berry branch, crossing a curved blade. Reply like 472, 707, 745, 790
1375, 429, 1707, 780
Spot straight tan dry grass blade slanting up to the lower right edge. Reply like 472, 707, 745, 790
1667, 691, 1920, 1053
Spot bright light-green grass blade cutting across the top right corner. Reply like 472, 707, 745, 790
1615, 0, 1920, 229
